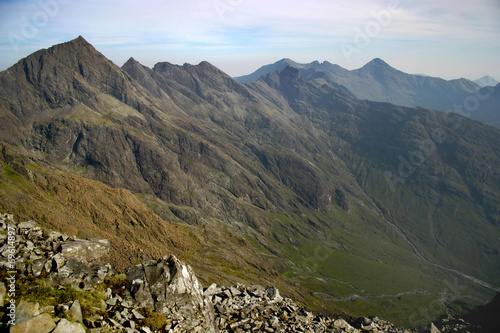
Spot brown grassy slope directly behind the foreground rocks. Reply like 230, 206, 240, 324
0, 142, 304, 294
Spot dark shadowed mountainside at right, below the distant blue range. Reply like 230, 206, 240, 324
252, 68, 500, 284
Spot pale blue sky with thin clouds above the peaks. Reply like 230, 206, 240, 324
0, 0, 500, 81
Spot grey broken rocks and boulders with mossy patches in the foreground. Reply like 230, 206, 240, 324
0, 214, 426, 333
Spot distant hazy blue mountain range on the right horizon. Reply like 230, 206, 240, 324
235, 58, 500, 127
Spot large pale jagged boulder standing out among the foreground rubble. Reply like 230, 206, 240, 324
124, 256, 216, 332
